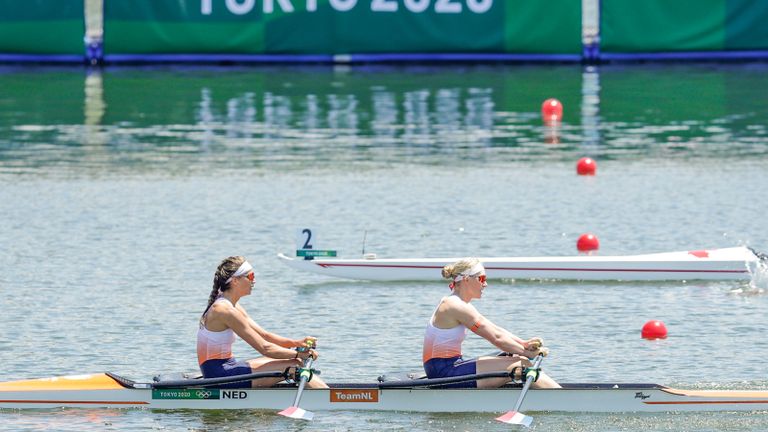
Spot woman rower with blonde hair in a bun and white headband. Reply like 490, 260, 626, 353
423, 258, 560, 388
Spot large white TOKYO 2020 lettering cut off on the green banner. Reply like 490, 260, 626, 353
200, 0, 493, 15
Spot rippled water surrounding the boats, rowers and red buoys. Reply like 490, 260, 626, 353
0, 64, 768, 430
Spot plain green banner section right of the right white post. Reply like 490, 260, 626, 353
600, 0, 768, 53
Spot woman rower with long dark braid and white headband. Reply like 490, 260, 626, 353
197, 256, 328, 388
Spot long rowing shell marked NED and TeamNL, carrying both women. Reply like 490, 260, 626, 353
0, 374, 768, 412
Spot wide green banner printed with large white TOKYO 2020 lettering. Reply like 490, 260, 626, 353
104, 0, 581, 54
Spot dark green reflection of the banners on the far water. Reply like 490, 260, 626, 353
0, 65, 768, 173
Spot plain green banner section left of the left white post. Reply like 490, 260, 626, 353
0, 0, 85, 54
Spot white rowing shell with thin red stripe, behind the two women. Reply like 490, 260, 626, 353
278, 247, 760, 281
